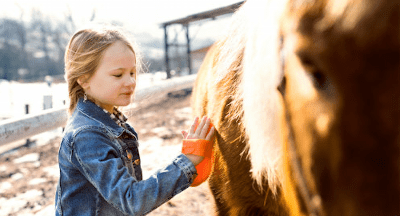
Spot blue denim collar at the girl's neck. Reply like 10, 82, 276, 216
76, 98, 125, 137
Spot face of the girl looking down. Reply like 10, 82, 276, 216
80, 41, 136, 113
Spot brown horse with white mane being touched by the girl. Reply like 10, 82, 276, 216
192, 0, 400, 216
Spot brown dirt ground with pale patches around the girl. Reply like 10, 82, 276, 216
0, 90, 214, 216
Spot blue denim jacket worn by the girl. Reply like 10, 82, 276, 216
55, 99, 197, 216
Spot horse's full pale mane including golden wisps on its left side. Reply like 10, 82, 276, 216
215, 0, 286, 195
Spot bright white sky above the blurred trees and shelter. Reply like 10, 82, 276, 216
0, 0, 240, 57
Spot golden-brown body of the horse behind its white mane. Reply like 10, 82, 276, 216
192, 40, 290, 216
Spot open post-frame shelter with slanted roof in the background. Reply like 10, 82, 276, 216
161, 1, 244, 78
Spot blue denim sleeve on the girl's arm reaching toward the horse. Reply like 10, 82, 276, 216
71, 127, 196, 215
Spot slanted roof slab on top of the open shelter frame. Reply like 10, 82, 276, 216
161, 1, 244, 27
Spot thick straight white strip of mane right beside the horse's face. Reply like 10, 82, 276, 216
241, 0, 287, 195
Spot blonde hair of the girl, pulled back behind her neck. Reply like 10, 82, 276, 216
64, 26, 142, 115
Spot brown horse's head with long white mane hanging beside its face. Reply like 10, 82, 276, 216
242, 0, 400, 215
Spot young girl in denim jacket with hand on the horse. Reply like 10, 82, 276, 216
55, 26, 214, 216
